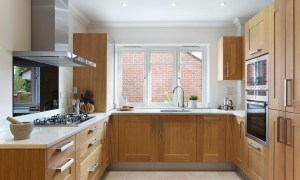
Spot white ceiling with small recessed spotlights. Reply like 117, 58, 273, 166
69, 0, 273, 24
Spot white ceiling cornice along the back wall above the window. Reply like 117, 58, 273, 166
88, 20, 235, 28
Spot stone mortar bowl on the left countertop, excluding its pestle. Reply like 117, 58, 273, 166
10, 122, 33, 140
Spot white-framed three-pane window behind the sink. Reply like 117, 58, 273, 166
116, 46, 207, 106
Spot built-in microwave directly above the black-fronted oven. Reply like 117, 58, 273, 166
246, 54, 269, 90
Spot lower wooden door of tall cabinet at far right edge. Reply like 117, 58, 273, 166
284, 113, 300, 180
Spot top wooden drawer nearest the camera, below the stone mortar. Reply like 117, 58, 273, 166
47, 136, 75, 165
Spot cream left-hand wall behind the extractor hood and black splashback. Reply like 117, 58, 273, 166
0, 0, 87, 130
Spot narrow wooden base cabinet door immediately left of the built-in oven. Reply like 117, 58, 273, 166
233, 117, 247, 170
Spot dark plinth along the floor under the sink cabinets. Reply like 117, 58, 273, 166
108, 162, 237, 171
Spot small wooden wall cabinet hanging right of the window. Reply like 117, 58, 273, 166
218, 36, 243, 80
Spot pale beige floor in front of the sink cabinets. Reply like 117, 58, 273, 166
103, 171, 243, 180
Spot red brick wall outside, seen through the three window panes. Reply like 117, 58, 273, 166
121, 52, 202, 103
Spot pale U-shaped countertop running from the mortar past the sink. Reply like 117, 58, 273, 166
0, 109, 245, 149
